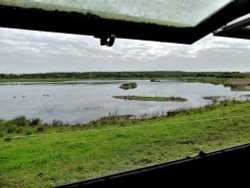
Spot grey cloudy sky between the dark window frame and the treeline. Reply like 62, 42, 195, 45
0, 28, 250, 73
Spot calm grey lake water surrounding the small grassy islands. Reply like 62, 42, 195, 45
0, 80, 250, 123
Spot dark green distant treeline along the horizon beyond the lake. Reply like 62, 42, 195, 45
0, 71, 250, 79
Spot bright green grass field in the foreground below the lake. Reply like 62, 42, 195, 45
0, 102, 250, 188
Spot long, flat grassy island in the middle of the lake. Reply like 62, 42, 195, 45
113, 95, 187, 102
